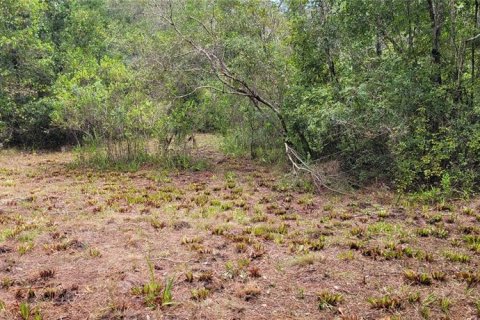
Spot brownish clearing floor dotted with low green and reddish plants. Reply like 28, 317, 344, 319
0, 136, 480, 319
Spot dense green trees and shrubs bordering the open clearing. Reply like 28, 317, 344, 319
0, 0, 480, 196
